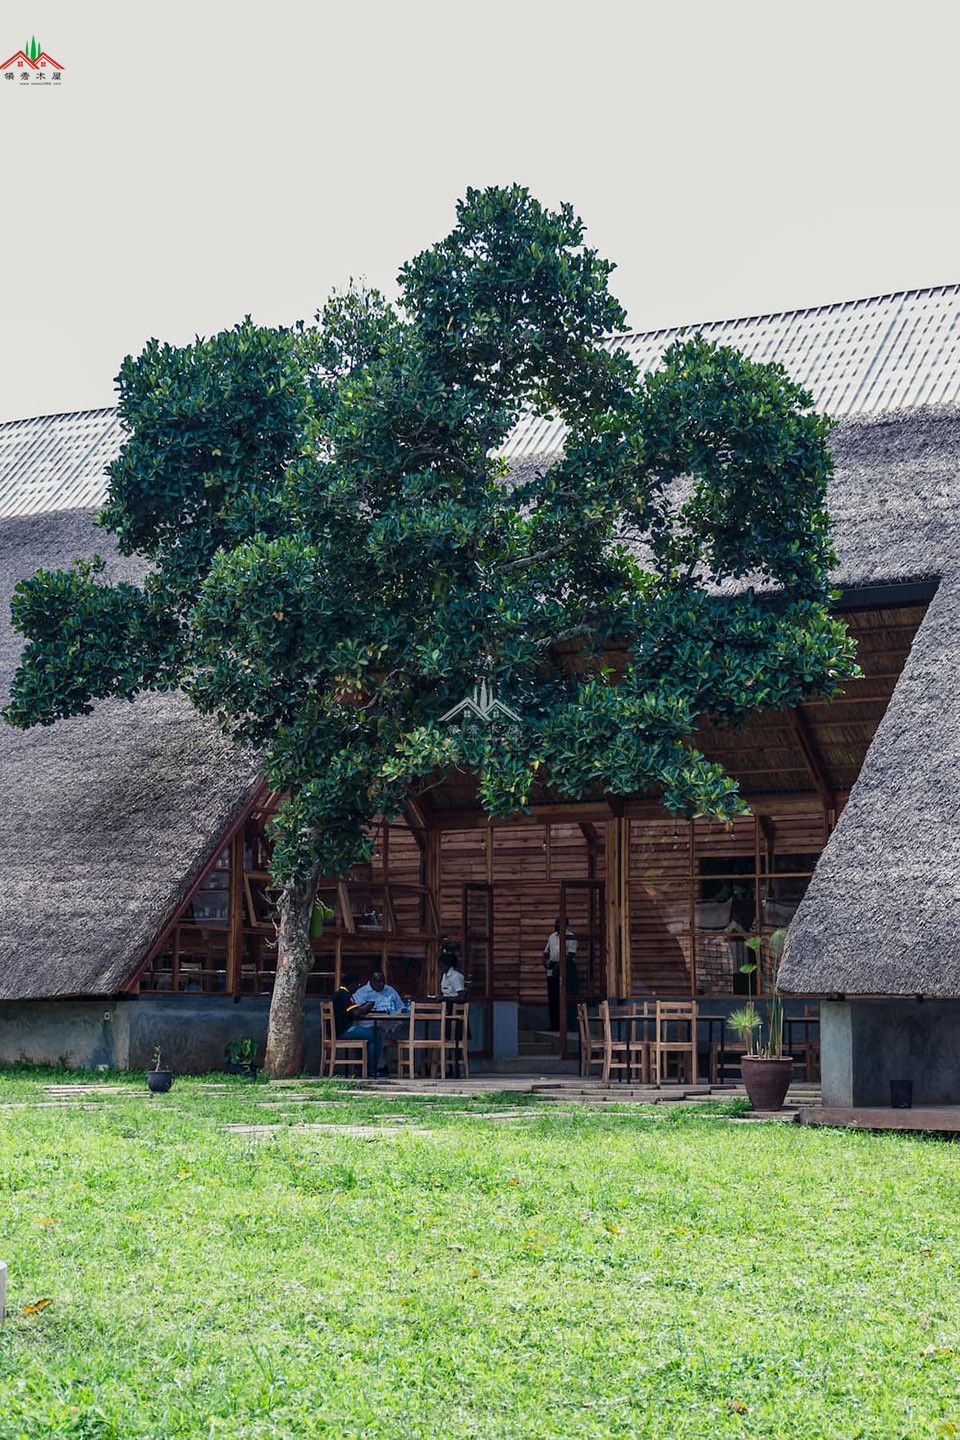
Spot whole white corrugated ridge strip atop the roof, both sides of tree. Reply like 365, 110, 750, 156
0, 285, 960, 518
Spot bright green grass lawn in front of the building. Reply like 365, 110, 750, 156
0, 1073, 960, 1440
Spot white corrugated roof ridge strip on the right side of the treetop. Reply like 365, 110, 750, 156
504, 285, 960, 459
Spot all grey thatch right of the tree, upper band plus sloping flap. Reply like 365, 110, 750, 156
780, 412, 960, 996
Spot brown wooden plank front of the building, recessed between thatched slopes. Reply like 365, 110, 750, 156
120, 600, 925, 1054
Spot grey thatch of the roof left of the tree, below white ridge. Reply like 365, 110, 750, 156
0, 510, 258, 999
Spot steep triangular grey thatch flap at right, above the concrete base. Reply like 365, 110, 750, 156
780, 567, 960, 996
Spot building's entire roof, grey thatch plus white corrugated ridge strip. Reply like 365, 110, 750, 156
0, 285, 960, 999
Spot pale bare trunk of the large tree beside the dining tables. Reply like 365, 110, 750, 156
263, 870, 320, 1080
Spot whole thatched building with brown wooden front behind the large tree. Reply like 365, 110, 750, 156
0, 287, 960, 1097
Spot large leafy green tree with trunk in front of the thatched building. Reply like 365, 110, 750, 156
6, 187, 855, 1076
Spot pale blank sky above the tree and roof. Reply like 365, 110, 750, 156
0, 0, 960, 419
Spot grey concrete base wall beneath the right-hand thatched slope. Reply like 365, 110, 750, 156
820, 999, 960, 1106
